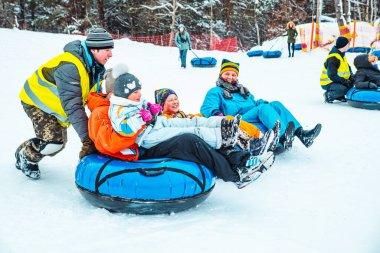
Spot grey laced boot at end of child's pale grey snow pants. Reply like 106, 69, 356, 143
220, 114, 241, 148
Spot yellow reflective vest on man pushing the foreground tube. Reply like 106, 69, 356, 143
20, 52, 100, 127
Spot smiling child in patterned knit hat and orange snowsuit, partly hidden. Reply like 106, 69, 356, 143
154, 88, 279, 155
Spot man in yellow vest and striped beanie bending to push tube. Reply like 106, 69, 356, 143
15, 28, 114, 179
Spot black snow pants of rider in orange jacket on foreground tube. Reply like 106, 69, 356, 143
139, 134, 239, 182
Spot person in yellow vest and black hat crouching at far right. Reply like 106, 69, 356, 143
320, 37, 354, 103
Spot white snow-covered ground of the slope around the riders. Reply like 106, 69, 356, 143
0, 29, 380, 253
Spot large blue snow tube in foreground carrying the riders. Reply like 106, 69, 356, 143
75, 154, 215, 214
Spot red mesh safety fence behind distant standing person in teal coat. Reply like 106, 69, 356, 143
128, 33, 238, 52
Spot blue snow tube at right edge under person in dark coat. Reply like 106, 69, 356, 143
346, 88, 380, 110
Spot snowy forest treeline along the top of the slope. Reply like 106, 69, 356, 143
0, 0, 380, 48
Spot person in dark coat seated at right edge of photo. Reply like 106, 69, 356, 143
354, 54, 380, 89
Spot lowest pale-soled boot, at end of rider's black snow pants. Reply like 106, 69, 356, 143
234, 152, 275, 189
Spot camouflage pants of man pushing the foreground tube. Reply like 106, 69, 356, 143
16, 104, 67, 162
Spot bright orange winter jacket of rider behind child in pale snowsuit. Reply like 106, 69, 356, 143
87, 92, 145, 161
